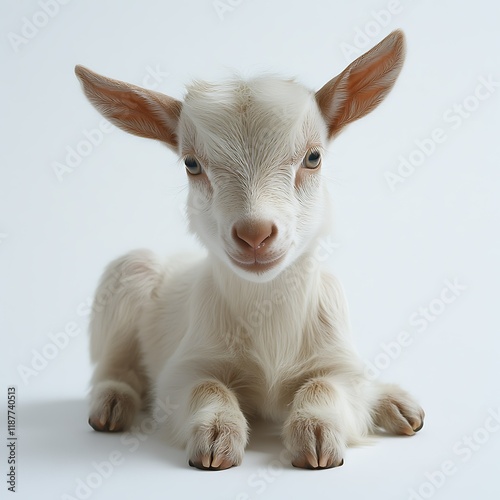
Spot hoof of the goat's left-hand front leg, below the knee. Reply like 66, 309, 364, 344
188, 420, 246, 470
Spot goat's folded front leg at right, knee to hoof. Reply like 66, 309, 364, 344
283, 377, 370, 469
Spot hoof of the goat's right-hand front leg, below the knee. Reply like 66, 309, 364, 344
284, 417, 345, 470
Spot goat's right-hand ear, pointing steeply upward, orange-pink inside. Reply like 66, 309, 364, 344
316, 30, 405, 138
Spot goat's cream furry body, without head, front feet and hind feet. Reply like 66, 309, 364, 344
91, 242, 408, 446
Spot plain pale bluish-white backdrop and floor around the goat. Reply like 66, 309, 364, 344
0, 0, 500, 500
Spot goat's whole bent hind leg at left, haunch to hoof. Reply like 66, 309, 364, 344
89, 250, 163, 432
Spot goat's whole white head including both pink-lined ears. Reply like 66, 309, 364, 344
76, 31, 404, 281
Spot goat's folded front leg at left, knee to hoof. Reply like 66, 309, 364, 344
186, 379, 248, 470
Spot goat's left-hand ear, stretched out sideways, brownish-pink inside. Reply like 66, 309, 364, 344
75, 66, 182, 151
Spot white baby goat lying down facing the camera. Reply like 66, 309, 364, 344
76, 31, 424, 470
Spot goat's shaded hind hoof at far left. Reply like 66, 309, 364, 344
89, 382, 140, 432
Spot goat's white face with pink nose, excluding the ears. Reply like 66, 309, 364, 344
179, 78, 327, 281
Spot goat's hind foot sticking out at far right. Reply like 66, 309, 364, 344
372, 382, 425, 436
